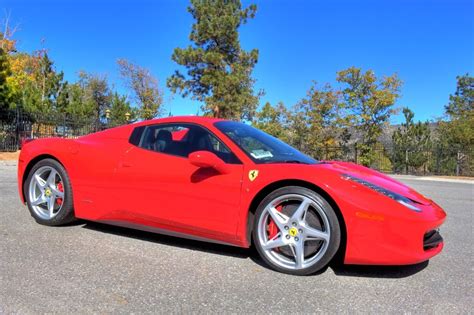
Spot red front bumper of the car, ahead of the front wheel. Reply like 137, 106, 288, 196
344, 202, 446, 265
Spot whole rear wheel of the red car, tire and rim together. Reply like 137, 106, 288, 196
23, 159, 75, 225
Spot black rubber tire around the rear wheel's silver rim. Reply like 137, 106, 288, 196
23, 159, 76, 226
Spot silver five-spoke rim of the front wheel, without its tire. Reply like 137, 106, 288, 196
257, 194, 331, 270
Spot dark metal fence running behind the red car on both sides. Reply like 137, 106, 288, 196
0, 111, 474, 176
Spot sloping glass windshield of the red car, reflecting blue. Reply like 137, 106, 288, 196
214, 121, 318, 164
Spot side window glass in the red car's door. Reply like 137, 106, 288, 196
138, 124, 241, 164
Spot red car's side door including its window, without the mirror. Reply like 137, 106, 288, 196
117, 123, 243, 241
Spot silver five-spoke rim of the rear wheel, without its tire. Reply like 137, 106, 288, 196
28, 166, 64, 220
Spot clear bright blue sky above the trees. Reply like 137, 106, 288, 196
0, 0, 474, 123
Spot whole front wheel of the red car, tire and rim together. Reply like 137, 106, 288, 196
252, 186, 341, 275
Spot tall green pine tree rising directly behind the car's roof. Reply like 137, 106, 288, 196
167, 0, 262, 121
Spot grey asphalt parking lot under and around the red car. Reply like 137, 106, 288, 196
0, 164, 474, 314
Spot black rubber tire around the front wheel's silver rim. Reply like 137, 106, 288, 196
252, 186, 341, 276
